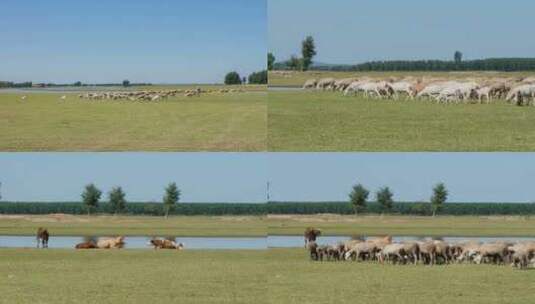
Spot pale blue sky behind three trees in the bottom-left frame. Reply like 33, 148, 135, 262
0, 153, 267, 203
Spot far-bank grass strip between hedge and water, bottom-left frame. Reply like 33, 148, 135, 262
0, 215, 267, 237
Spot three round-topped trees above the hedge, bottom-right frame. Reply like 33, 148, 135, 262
349, 183, 448, 216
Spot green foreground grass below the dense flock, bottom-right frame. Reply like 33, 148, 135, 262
267, 249, 535, 304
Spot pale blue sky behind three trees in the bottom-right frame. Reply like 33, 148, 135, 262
268, 153, 535, 202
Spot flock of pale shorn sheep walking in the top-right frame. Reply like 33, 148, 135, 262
303, 77, 535, 106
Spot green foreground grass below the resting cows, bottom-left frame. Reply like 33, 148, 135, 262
0, 249, 266, 304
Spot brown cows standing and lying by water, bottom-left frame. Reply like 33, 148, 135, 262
37, 228, 184, 250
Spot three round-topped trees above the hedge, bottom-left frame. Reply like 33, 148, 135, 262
81, 183, 181, 218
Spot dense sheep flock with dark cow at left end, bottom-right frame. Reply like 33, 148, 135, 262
305, 228, 535, 269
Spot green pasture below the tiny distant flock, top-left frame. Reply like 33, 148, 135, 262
0, 87, 267, 151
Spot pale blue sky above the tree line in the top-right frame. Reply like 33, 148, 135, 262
268, 0, 535, 63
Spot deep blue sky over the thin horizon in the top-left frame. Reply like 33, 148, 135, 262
0, 0, 267, 83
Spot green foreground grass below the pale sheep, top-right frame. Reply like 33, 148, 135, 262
268, 91, 535, 152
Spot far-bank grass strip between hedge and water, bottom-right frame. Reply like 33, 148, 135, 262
267, 215, 535, 237
